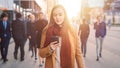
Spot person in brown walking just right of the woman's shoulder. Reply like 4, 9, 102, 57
78, 19, 90, 57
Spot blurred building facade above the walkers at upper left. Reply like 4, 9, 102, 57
0, 0, 41, 22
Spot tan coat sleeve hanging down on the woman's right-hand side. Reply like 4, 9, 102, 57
75, 30, 85, 68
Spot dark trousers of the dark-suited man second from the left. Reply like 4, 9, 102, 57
14, 38, 25, 59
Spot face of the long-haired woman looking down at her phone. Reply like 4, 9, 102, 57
53, 8, 64, 25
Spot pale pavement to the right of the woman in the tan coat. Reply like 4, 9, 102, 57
85, 27, 120, 68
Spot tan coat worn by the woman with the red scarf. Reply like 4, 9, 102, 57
39, 27, 85, 68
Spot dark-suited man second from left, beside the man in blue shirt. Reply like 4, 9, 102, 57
12, 13, 26, 61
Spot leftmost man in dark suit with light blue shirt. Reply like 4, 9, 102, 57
0, 13, 11, 63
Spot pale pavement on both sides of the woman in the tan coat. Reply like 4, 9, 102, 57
0, 26, 120, 68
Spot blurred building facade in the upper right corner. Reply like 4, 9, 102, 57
104, 0, 120, 24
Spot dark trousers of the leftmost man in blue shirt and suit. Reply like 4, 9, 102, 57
1, 37, 10, 60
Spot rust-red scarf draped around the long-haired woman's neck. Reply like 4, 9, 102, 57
44, 24, 72, 68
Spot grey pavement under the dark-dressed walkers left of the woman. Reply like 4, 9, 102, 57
0, 39, 43, 68
